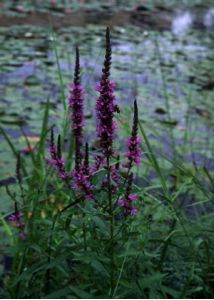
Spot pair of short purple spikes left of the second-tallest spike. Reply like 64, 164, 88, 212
48, 129, 70, 183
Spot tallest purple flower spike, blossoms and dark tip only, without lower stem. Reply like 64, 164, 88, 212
96, 28, 117, 156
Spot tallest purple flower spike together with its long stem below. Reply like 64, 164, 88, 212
95, 27, 118, 296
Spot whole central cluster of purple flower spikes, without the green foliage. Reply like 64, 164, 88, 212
46, 28, 142, 216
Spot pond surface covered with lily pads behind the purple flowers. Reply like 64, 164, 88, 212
0, 9, 214, 183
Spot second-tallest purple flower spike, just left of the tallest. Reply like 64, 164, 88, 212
69, 47, 84, 170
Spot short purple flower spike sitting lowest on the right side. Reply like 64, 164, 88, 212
117, 173, 137, 216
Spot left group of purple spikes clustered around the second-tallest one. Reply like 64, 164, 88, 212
49, 47, 94, 199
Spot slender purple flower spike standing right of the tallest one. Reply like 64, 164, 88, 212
123, 100, 142, 169
